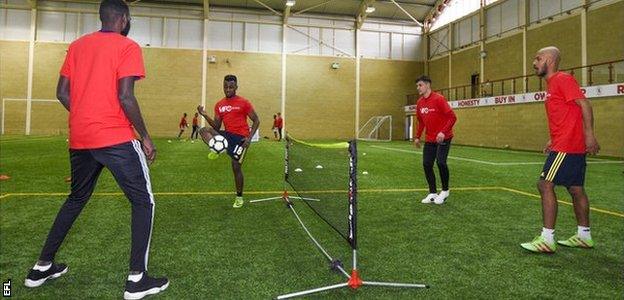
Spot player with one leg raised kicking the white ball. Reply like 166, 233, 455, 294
197, 75, 260, 208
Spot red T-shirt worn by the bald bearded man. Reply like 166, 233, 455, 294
544, 72, 586, 154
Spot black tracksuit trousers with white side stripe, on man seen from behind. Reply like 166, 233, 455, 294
39, 140, 155, 271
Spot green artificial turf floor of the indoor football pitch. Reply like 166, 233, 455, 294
0, 136, 624, 299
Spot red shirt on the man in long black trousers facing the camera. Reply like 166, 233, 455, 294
416, 92, 457, 143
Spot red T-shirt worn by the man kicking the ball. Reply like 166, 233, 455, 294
214, 95, 253, 137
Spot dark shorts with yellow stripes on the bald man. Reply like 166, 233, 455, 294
540, 151, 587, 187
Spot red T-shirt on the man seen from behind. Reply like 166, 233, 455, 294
60, 31, 145, 149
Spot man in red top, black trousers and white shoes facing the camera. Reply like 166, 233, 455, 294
414, 76, 457, 204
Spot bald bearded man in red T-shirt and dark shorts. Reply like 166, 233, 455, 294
521, 47, 600, 253
